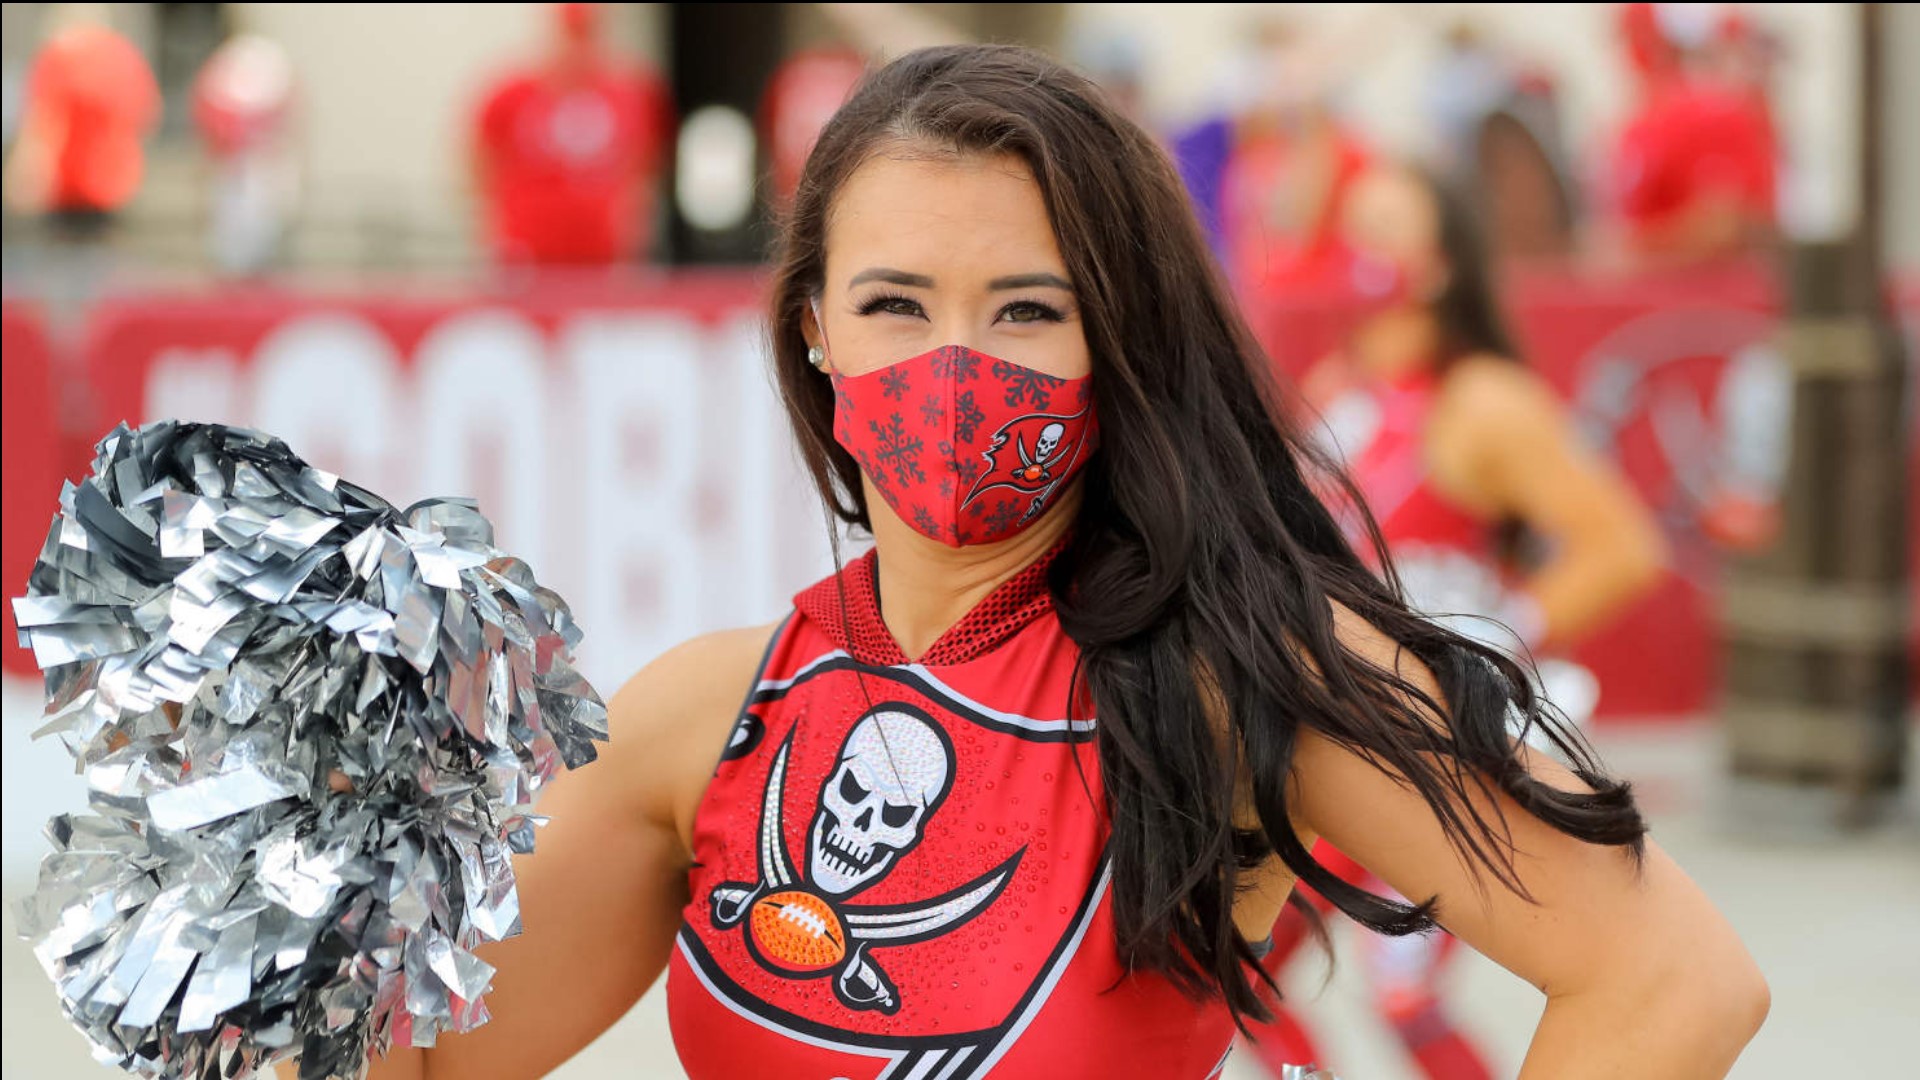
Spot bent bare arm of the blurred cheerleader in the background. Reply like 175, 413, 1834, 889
1428, 359, 1667, 646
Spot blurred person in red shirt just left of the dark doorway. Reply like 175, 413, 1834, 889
472, 4, 674, 265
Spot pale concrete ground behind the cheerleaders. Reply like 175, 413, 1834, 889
0, 724, 1920, 1080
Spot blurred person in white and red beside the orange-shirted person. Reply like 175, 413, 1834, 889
192, 22, 300, 275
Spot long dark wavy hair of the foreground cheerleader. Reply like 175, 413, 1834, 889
772, 46, 1645, 1022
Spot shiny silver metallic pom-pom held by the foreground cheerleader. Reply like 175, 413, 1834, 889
13, 421, 607, 1080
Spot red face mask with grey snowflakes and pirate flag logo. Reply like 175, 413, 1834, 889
833, 346, 1098, 548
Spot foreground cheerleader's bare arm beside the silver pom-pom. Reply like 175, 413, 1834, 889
345, 626, 770, 1080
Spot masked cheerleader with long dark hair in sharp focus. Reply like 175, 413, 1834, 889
353, 46, 1766, 1080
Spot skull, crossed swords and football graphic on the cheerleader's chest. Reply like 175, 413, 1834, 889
707, 703, 1025, 1015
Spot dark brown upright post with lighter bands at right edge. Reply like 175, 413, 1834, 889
1722, 4, 1910, 826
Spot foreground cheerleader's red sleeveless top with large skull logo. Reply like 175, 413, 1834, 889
666, 552, 1233, 1080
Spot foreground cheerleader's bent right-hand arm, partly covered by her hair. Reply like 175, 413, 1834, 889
1290, 609, 1768, 1080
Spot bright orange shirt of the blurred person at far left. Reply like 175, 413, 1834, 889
25, 25, 159, 209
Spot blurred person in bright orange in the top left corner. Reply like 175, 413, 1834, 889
6, 4, 159, 251
